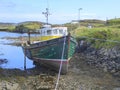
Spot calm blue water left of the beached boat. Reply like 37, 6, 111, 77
0, 32, 34, 70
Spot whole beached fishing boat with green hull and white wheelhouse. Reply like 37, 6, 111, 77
23, 9, 76, 73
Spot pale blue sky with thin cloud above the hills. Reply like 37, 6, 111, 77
0, 0, 120, 24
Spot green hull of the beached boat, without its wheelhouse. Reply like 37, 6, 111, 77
23, 35, 76, 73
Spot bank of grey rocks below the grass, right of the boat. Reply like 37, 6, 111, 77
78, 41, 120, 76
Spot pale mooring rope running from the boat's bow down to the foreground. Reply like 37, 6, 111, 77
55, 36, 66, 90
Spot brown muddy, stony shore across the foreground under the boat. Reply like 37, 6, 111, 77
0, 54, 120, 90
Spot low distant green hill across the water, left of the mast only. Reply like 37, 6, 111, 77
0, 21, 44, 32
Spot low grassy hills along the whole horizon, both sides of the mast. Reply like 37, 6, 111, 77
0, 18, 120, 32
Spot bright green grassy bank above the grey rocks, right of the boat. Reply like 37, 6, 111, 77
72, 27, 120, 48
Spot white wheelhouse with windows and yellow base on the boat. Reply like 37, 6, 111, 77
36, 25, 68, 41
